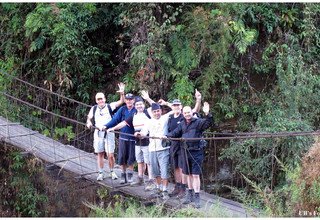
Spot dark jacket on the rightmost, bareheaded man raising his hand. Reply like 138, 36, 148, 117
167, 113, 213, 150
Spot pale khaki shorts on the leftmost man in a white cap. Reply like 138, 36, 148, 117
93, 129, 115, 154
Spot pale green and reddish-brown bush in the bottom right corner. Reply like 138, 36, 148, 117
233, 139, 320, 217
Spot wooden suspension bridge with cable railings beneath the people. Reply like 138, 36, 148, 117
0, 72, 320, 217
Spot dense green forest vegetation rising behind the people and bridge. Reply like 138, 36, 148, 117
0, 3, 320, 217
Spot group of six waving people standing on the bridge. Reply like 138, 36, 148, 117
87, 83, 213, 208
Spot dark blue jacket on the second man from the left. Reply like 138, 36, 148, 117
105, 105, 137, 140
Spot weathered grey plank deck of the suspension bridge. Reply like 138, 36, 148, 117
0, 117, 250, 217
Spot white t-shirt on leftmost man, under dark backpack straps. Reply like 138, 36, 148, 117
88, 102, 116, 127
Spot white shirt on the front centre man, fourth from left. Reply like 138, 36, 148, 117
141, 111, 172, 152
